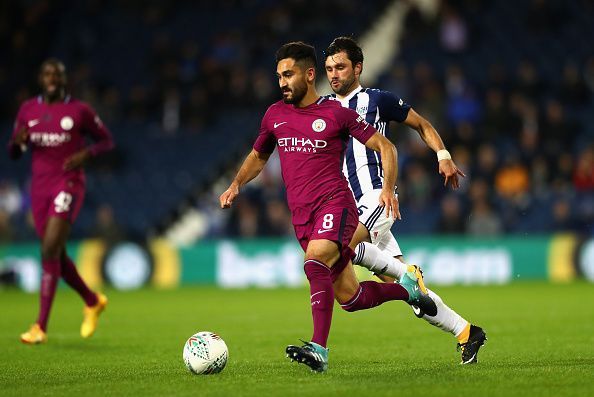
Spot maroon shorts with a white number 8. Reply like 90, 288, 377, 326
293, 191, 359, 281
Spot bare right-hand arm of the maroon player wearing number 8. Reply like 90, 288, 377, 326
365, 132, 401, 219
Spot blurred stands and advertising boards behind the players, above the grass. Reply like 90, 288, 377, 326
0, 0, 594, 289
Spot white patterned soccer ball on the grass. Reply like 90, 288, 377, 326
183, 331, 229, 375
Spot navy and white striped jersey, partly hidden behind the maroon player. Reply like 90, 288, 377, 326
331, 86, 410, 201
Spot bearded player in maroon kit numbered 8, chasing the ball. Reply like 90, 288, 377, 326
220, 42, 437, 372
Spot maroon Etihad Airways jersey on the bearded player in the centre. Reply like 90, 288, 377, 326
254, 98, 376, 224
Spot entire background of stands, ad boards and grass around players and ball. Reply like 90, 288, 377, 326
0, 0, 594, 397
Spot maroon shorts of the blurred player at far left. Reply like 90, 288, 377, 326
31, 180, 85, 237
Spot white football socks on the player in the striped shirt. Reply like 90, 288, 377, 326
353, 242, 468, 336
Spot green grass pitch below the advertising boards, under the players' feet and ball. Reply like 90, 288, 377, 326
0, 283, 594, 397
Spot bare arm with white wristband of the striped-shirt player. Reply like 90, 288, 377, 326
404, 109, 466, 189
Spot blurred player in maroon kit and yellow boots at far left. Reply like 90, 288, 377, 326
8, 59, 113, 344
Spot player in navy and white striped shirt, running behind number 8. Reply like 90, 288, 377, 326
325, 37, 486, 364
